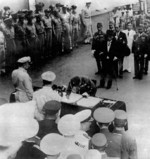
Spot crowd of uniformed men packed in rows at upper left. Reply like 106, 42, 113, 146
0, 5, 80, 71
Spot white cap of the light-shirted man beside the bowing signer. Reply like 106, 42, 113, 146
41, 71, 56, 82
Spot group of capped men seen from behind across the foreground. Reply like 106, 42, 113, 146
0, 100, 137, 159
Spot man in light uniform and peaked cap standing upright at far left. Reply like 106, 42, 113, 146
12, 57, 33, 102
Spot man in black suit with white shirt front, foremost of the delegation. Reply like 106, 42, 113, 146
98, 30, 117, 89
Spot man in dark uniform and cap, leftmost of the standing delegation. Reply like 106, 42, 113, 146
92, 23, 105, 74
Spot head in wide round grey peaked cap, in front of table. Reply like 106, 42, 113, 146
93, 107, 115, 129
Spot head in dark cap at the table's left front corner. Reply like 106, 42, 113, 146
43, 100, 61, 120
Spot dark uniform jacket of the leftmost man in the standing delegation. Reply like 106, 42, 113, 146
92, 32, 105, 54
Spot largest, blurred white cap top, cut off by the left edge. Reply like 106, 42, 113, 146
0, 117, 39, 146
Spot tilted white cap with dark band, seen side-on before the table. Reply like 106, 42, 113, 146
75, 109, 92, 123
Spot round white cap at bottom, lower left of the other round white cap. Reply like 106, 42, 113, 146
40, 133, 65, 156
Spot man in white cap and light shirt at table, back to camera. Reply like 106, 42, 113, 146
33, 71, 61, 121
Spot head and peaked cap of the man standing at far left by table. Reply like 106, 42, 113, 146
17, 56, 31, 70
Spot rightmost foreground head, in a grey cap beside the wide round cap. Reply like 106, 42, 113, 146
114, 110, 127, 131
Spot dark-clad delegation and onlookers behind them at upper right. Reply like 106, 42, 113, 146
92, 6, 150, 89
